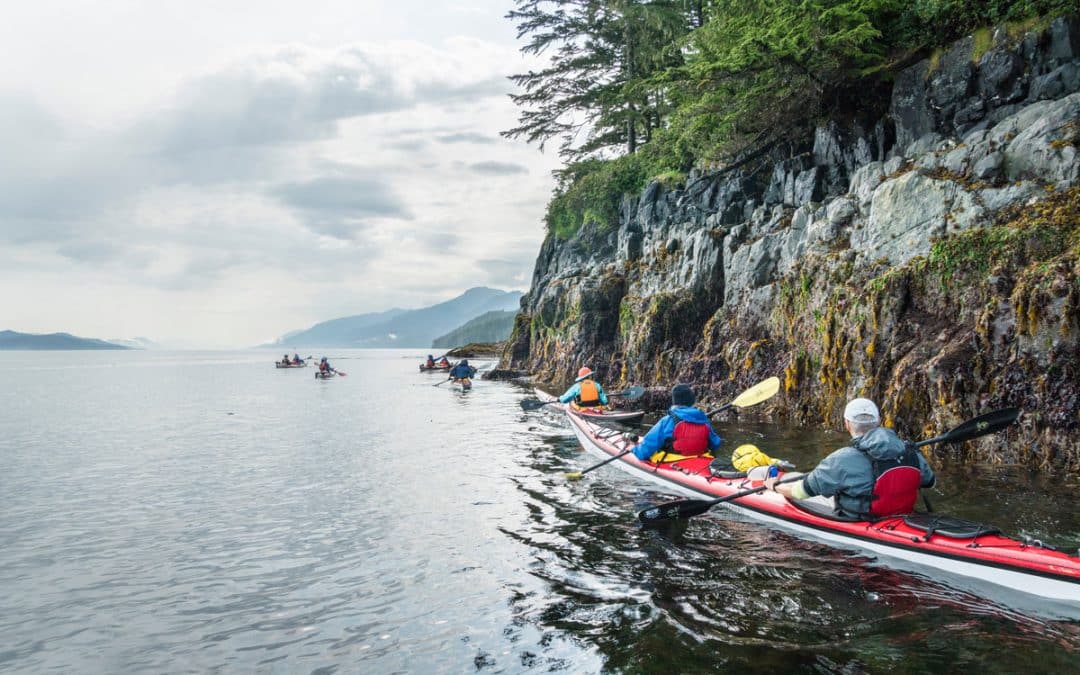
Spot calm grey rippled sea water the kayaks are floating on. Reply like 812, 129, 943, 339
0, 351, 1080, 673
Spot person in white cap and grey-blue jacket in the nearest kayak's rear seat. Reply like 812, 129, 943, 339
765, 399, 935, 517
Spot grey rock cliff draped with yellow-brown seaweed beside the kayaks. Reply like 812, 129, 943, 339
502, 18, 1080, 470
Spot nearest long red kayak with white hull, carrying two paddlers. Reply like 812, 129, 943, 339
567, 414, 1080, 617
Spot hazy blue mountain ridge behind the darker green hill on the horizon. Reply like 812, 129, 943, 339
273, 287, 522, 348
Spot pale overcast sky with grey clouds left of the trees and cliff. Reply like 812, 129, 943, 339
0, 0, 558, 347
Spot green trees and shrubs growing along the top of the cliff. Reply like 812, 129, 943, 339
503, 0, 1075, 240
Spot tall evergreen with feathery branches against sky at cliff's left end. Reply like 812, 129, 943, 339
503, 0, 689, 159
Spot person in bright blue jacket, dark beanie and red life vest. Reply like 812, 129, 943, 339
634, 384, 723, 463
